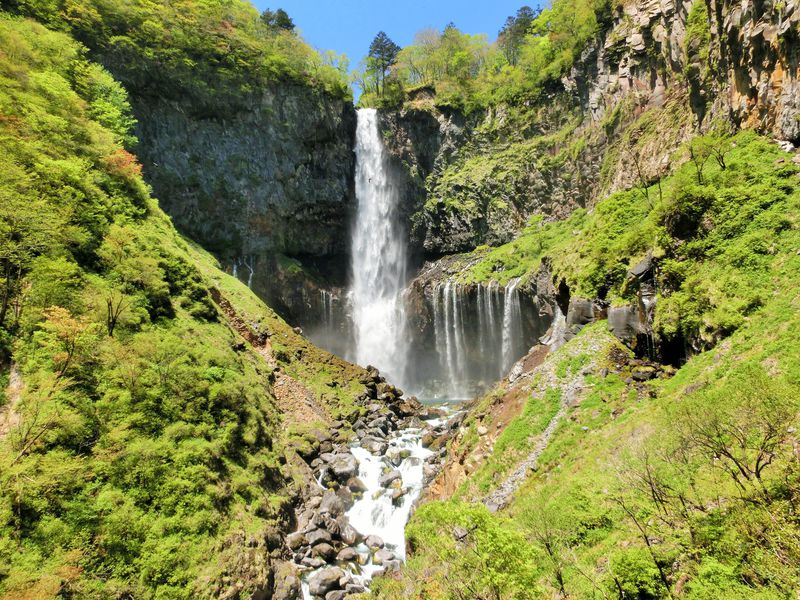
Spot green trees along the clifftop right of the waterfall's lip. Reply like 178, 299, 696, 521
360, 0, 611, 112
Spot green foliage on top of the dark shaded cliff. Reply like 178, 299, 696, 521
4, 0, 350, 110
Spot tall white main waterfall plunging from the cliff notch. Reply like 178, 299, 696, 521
351, 108, 407, 383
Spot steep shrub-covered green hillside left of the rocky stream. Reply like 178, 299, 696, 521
0, 15, 358, 598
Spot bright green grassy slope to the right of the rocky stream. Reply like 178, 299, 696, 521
378, 126, 800, 598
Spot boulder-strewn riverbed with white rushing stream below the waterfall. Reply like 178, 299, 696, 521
276, 368, 462, 600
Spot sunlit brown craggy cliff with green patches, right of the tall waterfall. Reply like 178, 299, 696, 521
376, 0, 800, 256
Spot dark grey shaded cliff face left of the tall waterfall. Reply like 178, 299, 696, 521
134, 84, 355, 263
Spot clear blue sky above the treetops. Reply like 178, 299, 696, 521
253, 0, 541, 69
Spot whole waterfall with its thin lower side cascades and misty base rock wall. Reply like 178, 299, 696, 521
307, 109, 543, 401
